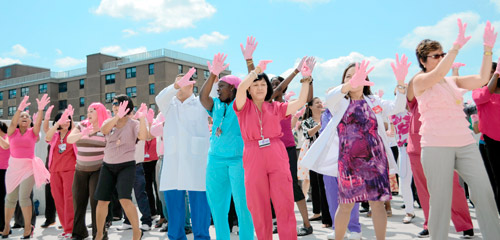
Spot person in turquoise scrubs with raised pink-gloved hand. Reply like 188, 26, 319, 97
200, 53, 254, 240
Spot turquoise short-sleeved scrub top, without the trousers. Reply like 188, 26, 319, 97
208, 98, 243, 157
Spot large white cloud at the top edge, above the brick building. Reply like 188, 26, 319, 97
94, 0, 217, 33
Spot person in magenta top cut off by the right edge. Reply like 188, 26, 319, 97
472, 63, 500, 213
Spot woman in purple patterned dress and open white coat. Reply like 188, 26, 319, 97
302, 55, 409, 240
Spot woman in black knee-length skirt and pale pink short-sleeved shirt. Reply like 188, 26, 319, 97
94, 94, 148, 240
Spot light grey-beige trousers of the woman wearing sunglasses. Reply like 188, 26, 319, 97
422, 144, 500, 240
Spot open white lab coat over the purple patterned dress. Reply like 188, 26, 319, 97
300, 85, 406, 177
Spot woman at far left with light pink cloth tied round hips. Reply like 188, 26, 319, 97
2, 94, 50, 239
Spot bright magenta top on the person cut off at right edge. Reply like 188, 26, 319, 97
472, 87, 500, 141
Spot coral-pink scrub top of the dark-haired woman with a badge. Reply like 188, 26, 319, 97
233, 98, 288, 142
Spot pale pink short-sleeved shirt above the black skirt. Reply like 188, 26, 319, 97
104, 118, 139, 164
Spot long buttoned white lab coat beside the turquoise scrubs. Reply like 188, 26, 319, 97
156, 84, 210, 191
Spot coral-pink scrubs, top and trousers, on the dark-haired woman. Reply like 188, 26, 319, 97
233, 99, 297, 240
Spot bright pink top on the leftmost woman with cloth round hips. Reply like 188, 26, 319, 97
9, 128, 38, 158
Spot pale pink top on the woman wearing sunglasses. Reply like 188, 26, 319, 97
417, 77, 476, 147
